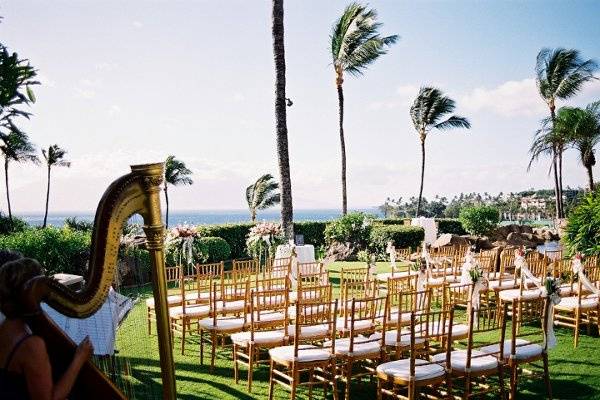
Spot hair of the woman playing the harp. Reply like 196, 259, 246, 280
0, 258, 43, 318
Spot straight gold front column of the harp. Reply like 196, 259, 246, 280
143, 164, 177, 400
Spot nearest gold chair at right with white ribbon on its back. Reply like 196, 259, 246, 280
480, 296, 552, 399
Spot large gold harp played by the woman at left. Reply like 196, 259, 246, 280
22, 164, 176, 400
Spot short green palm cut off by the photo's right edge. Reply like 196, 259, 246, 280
555, 101, 600, 191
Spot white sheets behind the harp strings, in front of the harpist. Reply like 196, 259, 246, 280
42, 288, 133, 355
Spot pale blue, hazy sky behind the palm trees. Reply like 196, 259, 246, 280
0, 0, 600, 214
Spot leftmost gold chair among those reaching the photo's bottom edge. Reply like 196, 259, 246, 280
269, 300, 338, 400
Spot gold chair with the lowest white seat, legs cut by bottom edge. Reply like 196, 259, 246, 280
376, 309, 454, 400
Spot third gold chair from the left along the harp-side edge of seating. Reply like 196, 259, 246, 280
198, 274, 250, 371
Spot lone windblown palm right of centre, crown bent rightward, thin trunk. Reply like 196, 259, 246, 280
410, 87, 471, 217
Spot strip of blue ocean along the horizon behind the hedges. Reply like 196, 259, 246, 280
22, 207, 382, 226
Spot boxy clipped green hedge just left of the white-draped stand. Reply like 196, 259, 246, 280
369, 225, 425, 258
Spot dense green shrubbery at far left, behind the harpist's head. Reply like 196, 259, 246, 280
0, 227, 91, 275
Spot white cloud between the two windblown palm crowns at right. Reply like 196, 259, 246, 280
458, 78, 547, 117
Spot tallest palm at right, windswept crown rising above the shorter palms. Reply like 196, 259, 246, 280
535, 48, 598, 218
